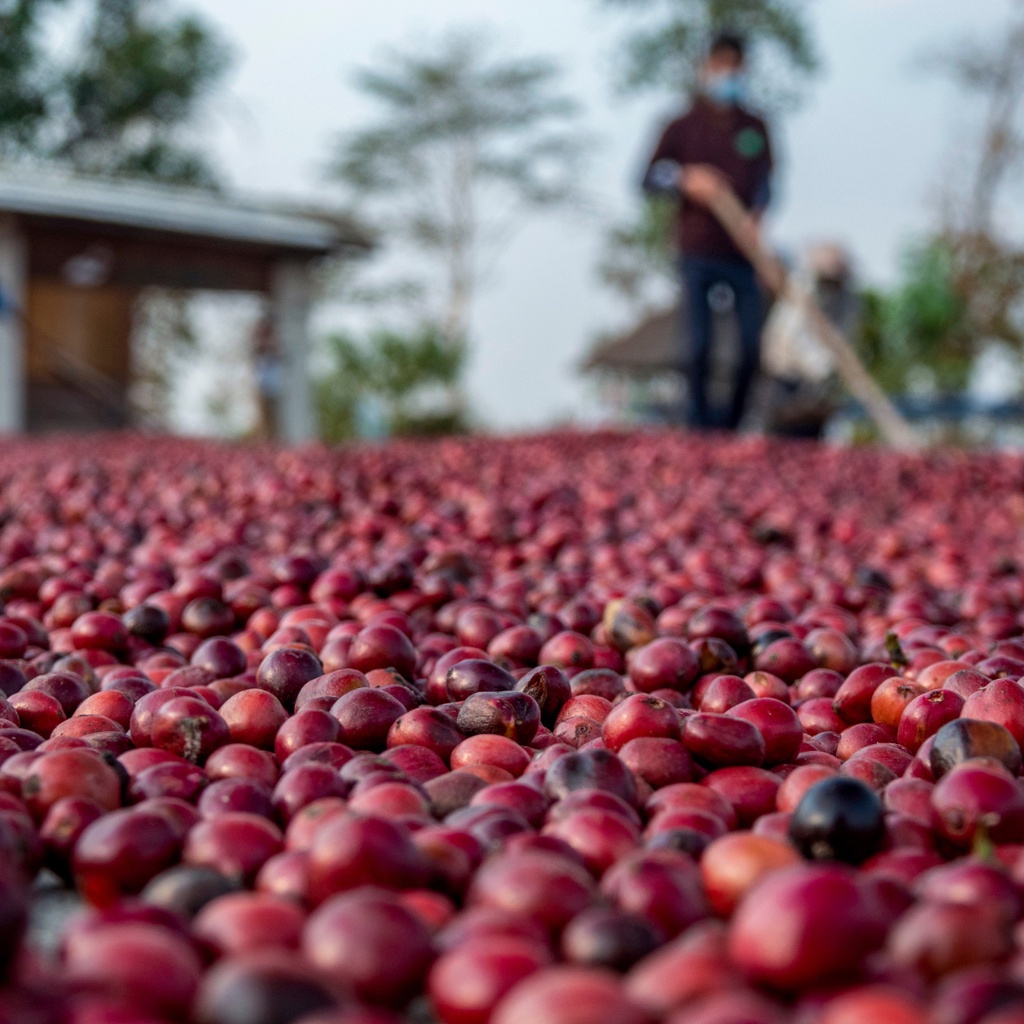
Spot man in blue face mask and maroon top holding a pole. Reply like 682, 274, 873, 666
643, 33, 772, 430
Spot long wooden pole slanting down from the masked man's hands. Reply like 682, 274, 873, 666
708, 186, 923, 449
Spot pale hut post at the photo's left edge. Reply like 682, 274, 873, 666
0, 217, 28, 433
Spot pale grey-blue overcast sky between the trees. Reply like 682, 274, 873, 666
189, 0, 1012, 428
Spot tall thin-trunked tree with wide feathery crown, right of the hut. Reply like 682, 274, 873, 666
333, 32, 583, 345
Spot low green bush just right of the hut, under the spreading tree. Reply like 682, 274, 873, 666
316, 327, 466, 441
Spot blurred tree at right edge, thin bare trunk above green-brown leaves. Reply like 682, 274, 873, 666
861, 0, 1024, 399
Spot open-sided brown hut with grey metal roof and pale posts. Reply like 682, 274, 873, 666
0, 171, 370, 441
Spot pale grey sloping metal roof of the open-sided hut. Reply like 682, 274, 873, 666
0, 168, 371, 256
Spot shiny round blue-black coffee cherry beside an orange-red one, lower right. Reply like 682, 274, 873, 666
790, 775, 886, 864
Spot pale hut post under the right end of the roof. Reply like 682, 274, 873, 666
270, 260, 315, 443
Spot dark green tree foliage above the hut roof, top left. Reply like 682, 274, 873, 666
0, 0, 228, 187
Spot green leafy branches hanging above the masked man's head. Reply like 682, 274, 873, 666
599, 0, 817, 101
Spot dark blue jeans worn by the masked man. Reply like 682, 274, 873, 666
681, 256, 764, 430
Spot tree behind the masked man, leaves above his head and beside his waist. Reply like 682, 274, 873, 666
598, 0, 817, 317
